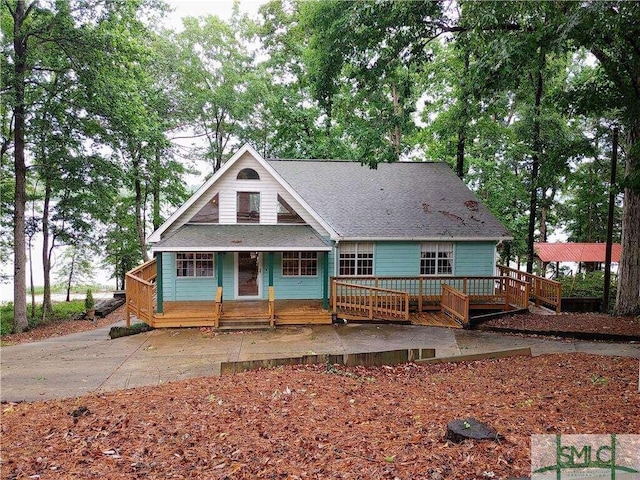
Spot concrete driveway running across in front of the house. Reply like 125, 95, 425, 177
0, 324, 640, 402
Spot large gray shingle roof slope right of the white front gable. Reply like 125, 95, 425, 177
269, 160, 511, 239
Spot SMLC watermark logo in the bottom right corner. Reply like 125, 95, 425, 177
531, 434, 640, 480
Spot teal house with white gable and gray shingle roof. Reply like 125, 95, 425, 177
125, 145, 556, 326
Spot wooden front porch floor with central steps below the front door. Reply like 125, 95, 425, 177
153, 300, 331, 328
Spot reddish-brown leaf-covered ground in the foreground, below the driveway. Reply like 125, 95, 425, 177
1, 354, 640, 479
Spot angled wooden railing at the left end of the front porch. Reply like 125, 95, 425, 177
125, 259, 158, 327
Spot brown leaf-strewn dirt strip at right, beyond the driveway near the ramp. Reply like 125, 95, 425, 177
482, 313, 640, 337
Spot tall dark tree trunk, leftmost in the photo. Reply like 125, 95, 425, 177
13, 0, 29, 333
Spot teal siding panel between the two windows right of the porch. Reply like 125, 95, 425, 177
373, 242, 420, 277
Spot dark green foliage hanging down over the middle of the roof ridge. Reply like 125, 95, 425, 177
301, 0, 442, 165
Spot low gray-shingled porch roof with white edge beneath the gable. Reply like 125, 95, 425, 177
152, 224, 331, 252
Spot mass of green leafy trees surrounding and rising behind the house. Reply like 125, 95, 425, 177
0, 0, 640, 331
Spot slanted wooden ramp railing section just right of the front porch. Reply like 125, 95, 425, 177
331, 279, 409, 320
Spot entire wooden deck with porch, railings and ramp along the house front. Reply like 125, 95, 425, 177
126, 260, 561, 328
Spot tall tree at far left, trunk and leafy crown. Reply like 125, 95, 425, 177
2, 0, 170, 331
